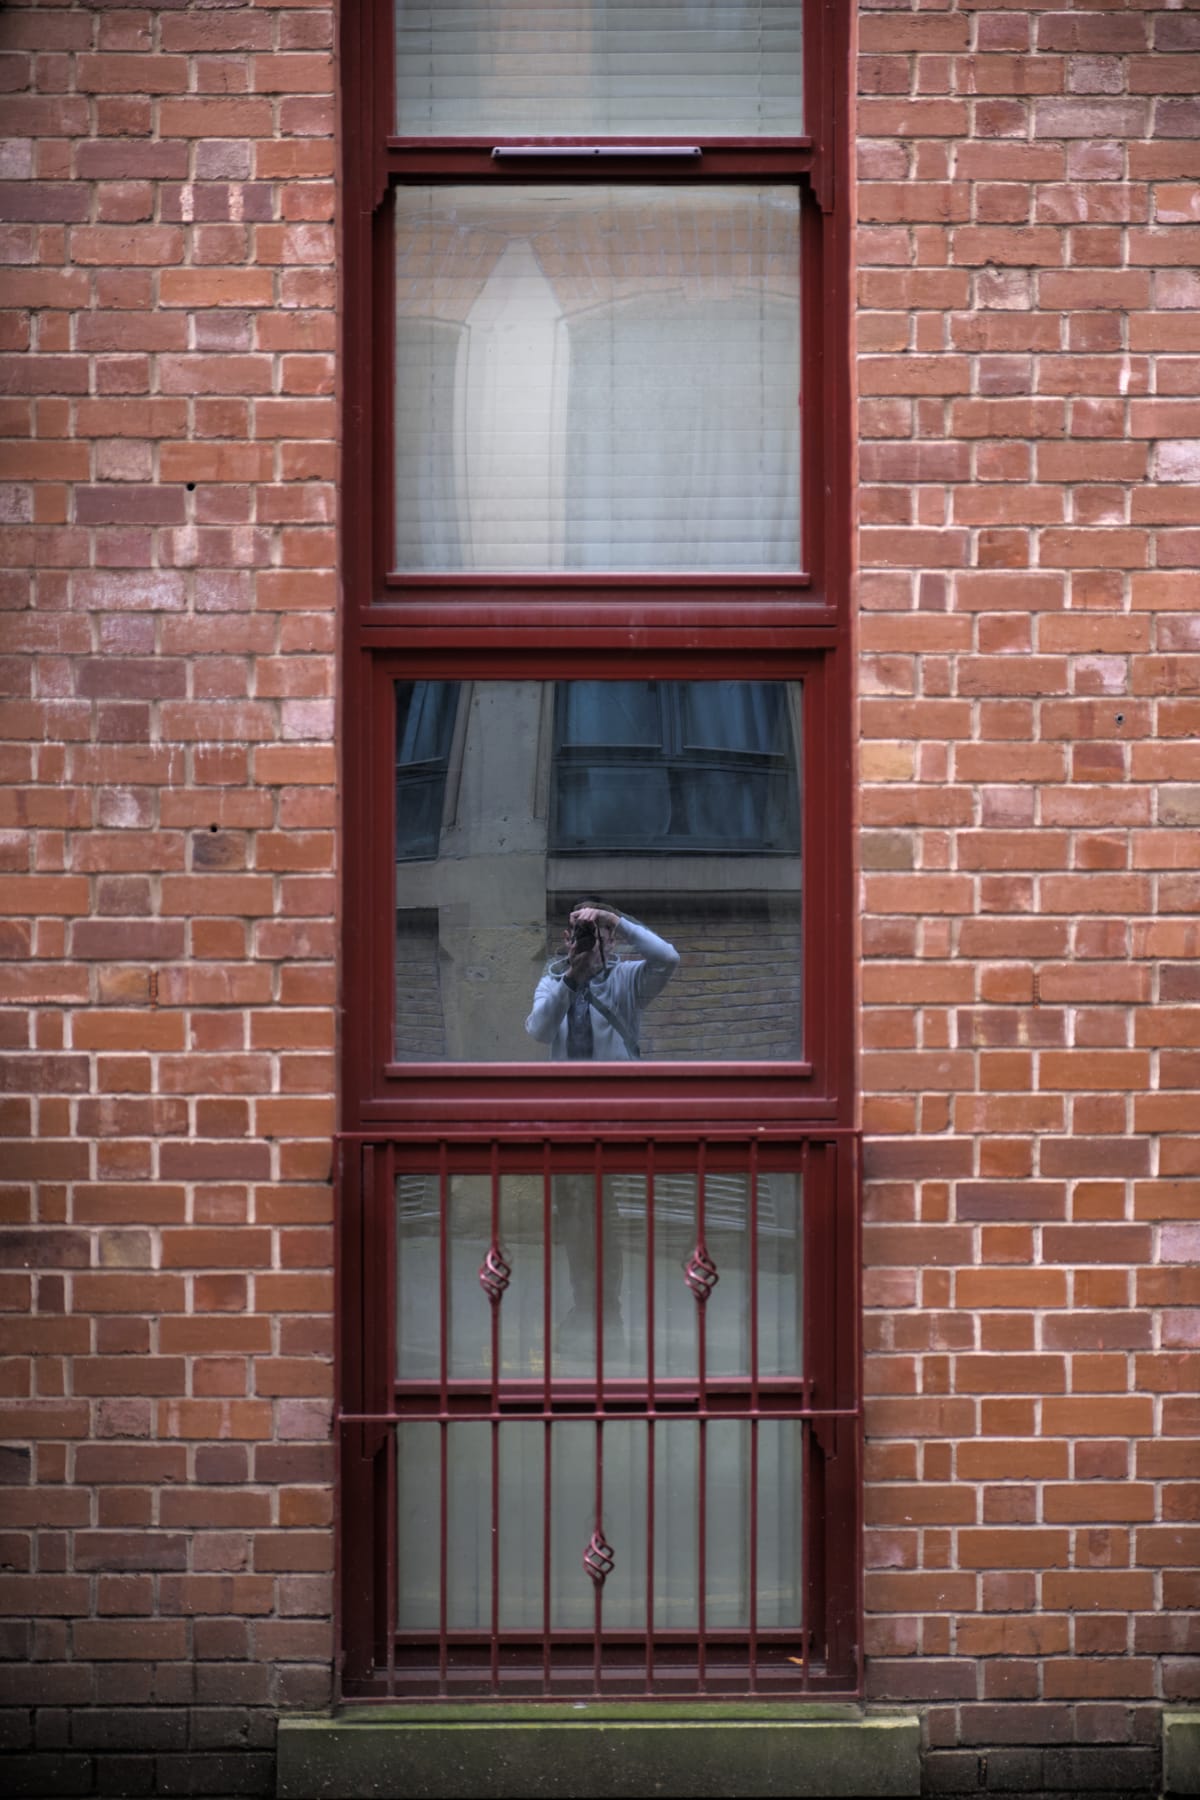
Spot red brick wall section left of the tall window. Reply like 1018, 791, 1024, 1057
0, 0, 336, 1795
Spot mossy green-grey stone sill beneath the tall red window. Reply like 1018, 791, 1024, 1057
275, 1701, 921, 1800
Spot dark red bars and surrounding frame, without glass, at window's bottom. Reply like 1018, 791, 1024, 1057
338, 1130, 862, 1701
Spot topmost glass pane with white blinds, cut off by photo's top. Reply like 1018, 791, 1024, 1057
396, 0, 802, 137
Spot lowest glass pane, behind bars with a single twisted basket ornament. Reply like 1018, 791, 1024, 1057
396, 1418, 804, 1649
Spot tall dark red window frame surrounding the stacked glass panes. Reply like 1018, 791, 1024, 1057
338, 0, 862, 1699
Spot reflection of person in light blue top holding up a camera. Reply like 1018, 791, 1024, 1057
525, 898, 678, 1062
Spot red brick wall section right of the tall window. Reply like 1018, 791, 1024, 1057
856, 0, 1200, 1789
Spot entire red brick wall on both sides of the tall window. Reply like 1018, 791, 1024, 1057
0, 0, 1200, 1791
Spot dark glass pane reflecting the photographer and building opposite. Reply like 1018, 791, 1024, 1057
394, 680, 802, 1062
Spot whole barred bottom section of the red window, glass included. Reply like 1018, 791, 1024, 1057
338, 1132, 860, 1701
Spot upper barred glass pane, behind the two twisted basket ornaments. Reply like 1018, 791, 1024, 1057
396, 1170, 802, 1381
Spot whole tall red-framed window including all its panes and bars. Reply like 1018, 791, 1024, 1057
338, 0, 860, 1701
